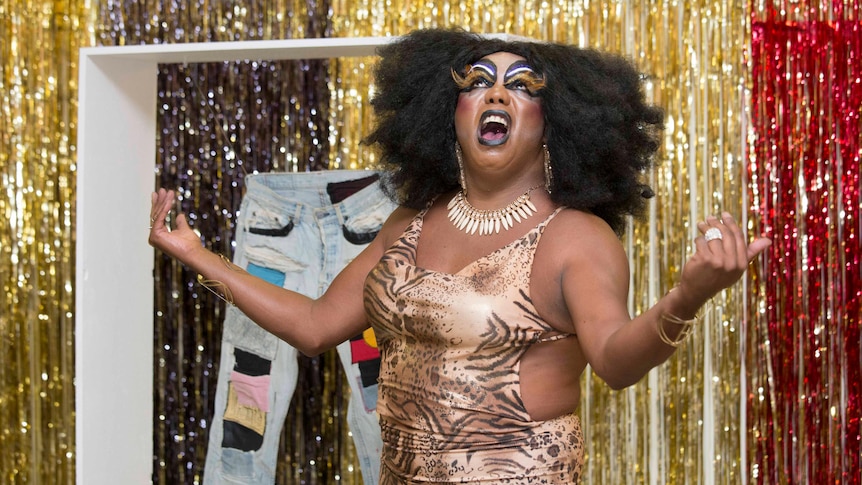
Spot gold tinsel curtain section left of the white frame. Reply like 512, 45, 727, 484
0, 0, 92, 484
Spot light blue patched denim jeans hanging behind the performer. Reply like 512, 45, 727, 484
204, 170, 395, 485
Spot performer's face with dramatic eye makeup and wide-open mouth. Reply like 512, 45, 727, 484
453, 52, 545, 182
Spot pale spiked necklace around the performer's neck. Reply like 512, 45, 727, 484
446, 185, 542, 236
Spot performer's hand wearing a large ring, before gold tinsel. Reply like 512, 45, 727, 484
678, 212, 772, 306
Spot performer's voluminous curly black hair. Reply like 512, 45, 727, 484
365, 29, 663, 234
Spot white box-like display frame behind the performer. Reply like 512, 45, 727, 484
75, 37, 393, 485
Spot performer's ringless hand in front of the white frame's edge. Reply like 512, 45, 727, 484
149, 189, 203, 262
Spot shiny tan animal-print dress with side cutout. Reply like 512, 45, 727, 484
364, 206, 583, 485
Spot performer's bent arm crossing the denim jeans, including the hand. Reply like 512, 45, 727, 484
149, 189, 412, 355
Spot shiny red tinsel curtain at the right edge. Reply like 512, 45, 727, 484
749, 2, 862, 484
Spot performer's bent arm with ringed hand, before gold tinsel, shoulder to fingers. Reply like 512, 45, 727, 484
563, 213, 770, 389
